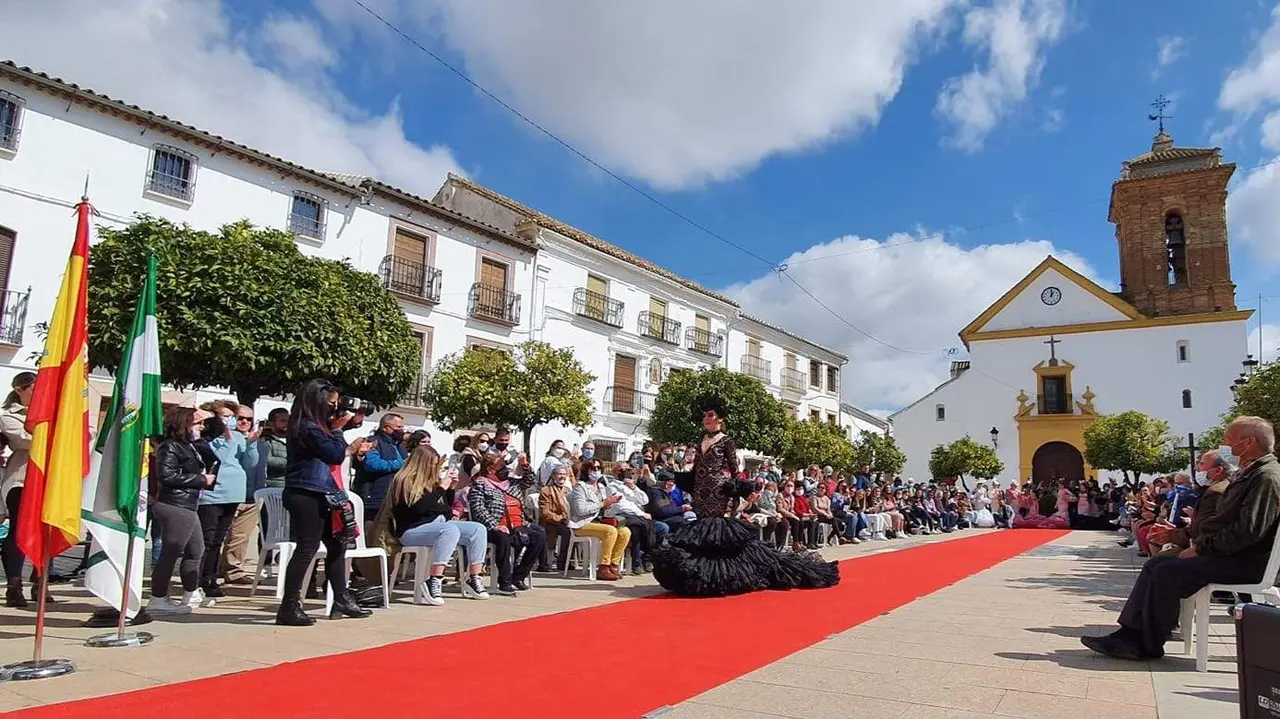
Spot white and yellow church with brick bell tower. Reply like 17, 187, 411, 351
891, 132, 1252, 482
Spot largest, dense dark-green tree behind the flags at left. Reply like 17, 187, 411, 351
88, 216, 421, 407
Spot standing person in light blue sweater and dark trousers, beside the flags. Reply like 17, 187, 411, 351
195, 399, 257, 605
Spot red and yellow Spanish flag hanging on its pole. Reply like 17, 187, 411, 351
17, 197, 92, 572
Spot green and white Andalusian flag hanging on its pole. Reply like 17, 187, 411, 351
83, 257, 164, 617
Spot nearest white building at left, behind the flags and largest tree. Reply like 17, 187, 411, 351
0, 63, 535, 434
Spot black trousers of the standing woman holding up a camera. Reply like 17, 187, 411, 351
280, 487, 347, 604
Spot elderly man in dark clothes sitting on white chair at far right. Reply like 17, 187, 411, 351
1080, 417, 1280, 660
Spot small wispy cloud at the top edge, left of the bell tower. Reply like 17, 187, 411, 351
937, 0, 1066, 152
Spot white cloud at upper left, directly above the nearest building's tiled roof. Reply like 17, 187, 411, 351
0, 0, 458, 196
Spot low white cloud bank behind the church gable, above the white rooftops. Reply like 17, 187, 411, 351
726, 230, 1106, 411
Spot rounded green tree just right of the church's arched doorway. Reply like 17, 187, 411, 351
1084, 409, 1188, 481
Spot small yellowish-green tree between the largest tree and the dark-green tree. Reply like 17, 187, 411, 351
422, 340, 595, 452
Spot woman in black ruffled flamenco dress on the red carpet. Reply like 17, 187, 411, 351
653, 398, 840, 596
